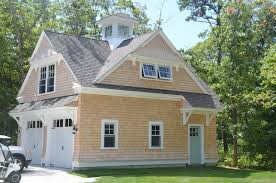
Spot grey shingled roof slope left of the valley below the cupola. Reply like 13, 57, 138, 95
45, 31, 111, 86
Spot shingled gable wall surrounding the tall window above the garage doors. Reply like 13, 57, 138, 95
22, 61, 75, 102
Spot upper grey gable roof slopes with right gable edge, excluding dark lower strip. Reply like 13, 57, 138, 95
23, 30, 222, 108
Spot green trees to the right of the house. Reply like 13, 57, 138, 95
179, 0, 276, 168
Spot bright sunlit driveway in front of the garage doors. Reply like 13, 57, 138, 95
0, 166, 96, 183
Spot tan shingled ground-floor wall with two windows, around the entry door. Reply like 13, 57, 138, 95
74, 94, 217, 162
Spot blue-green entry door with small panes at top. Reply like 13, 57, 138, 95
189, 126, 202, 165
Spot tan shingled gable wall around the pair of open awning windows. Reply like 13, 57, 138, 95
102, 61, 202, 93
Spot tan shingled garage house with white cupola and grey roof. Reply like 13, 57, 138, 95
10, 14, 221, 169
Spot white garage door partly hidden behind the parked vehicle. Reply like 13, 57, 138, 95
26, 121, 42, 164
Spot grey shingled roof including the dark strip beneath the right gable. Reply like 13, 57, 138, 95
41, 30, 222, 108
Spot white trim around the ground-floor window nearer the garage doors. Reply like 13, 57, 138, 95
101, 119, 119, 149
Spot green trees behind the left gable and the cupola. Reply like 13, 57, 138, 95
0, 0, 150, 141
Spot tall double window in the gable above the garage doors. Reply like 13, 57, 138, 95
39, 64, 55, 94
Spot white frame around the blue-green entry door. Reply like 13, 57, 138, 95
188, 123, 205, 165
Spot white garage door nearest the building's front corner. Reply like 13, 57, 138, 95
51, 119, 73, 168
